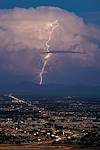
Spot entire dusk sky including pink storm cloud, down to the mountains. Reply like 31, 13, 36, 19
0, 0, 100, 85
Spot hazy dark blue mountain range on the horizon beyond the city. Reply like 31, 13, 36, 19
0, 82, 100, 97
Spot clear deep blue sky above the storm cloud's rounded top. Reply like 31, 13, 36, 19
0, 0, 100, 24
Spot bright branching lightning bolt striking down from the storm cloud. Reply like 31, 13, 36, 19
40, 20, 59, 85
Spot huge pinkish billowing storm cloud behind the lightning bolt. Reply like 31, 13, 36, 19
0, 7, 100, 79
